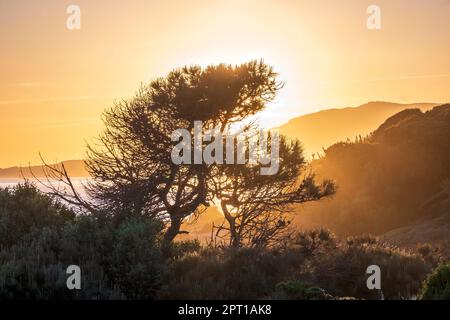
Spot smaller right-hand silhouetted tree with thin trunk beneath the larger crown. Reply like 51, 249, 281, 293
211, 137, 334, 247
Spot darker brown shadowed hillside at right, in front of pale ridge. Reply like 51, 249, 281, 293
296, 104, 450, 244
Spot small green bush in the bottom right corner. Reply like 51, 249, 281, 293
420, 263, 450, 300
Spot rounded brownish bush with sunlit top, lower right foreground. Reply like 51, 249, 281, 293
310, 237, 430, 299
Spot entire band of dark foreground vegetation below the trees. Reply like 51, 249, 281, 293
0, 184, 448, 299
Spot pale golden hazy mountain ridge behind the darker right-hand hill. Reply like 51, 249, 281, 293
278, 102, 438, 155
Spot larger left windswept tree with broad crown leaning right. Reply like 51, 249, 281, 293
41, 61, 281, 248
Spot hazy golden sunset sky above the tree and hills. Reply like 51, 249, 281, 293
0, 0, 450, 167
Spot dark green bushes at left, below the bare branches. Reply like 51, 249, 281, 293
0, 185, 164, 299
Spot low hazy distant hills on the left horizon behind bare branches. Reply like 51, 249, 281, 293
0, 160, 89, 179
